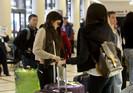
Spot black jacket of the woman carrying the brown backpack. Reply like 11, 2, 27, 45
66, 22, 115, 72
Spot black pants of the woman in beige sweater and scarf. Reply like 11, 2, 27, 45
37, 64, 53, 89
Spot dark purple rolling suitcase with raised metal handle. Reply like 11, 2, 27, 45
44, 65, 85, 93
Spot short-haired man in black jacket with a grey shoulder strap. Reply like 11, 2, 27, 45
13, 14, 38, 68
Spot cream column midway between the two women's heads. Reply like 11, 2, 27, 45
71, 0, 80, 40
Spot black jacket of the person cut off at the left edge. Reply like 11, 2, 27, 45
0, 36, 9, 55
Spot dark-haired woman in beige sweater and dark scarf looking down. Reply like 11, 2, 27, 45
33, 11, 63, 89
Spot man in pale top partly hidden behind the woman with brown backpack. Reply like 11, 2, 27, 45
108, 11, 123, 93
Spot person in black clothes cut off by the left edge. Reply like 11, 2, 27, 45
0, 32, 10, 76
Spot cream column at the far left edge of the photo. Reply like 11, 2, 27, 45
0, 0, 11, 37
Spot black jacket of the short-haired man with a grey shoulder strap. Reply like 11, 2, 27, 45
13, 25, 37, 59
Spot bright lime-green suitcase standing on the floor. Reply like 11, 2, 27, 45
15, 68, 40, 93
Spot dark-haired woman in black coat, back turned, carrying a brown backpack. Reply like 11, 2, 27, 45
58, 3, 115, 93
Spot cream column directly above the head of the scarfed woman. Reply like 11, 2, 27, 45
56, 0, 66, 16
